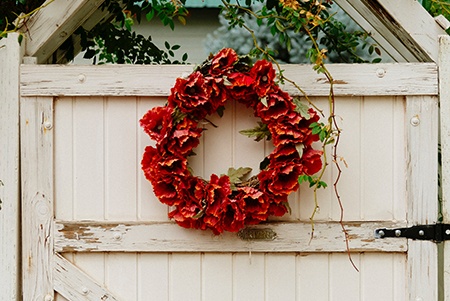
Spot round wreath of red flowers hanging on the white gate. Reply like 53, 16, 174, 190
140, 48, 322, 234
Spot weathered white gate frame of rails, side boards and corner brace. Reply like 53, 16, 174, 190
14, 63, 438, 300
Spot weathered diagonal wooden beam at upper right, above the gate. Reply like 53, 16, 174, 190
335, 0, 446, 62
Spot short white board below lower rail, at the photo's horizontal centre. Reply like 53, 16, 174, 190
202, 253, 233, 301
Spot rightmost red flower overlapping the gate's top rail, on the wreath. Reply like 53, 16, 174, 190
250, 60, 275, 97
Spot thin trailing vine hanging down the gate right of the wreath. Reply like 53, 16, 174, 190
222, 0, 358, 270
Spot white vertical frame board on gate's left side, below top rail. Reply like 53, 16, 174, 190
20, 98, 54, 300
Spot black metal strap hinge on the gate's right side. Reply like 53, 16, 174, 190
375, 224, 450, 242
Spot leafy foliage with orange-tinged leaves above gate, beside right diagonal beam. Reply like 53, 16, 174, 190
218, 0, 381, 63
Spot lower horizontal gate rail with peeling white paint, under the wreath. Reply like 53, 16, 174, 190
54, 221, 407, 253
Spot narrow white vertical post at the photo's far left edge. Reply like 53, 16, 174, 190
0, 34, 22, 300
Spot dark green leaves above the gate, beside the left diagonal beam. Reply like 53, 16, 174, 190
75, 0, 187, 64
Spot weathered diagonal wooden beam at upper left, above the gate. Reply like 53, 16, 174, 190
22, 0, 104, 63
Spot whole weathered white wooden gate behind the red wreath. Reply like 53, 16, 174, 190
20, 59, 438, 301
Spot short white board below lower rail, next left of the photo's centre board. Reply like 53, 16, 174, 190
169, 253, 202, 301
